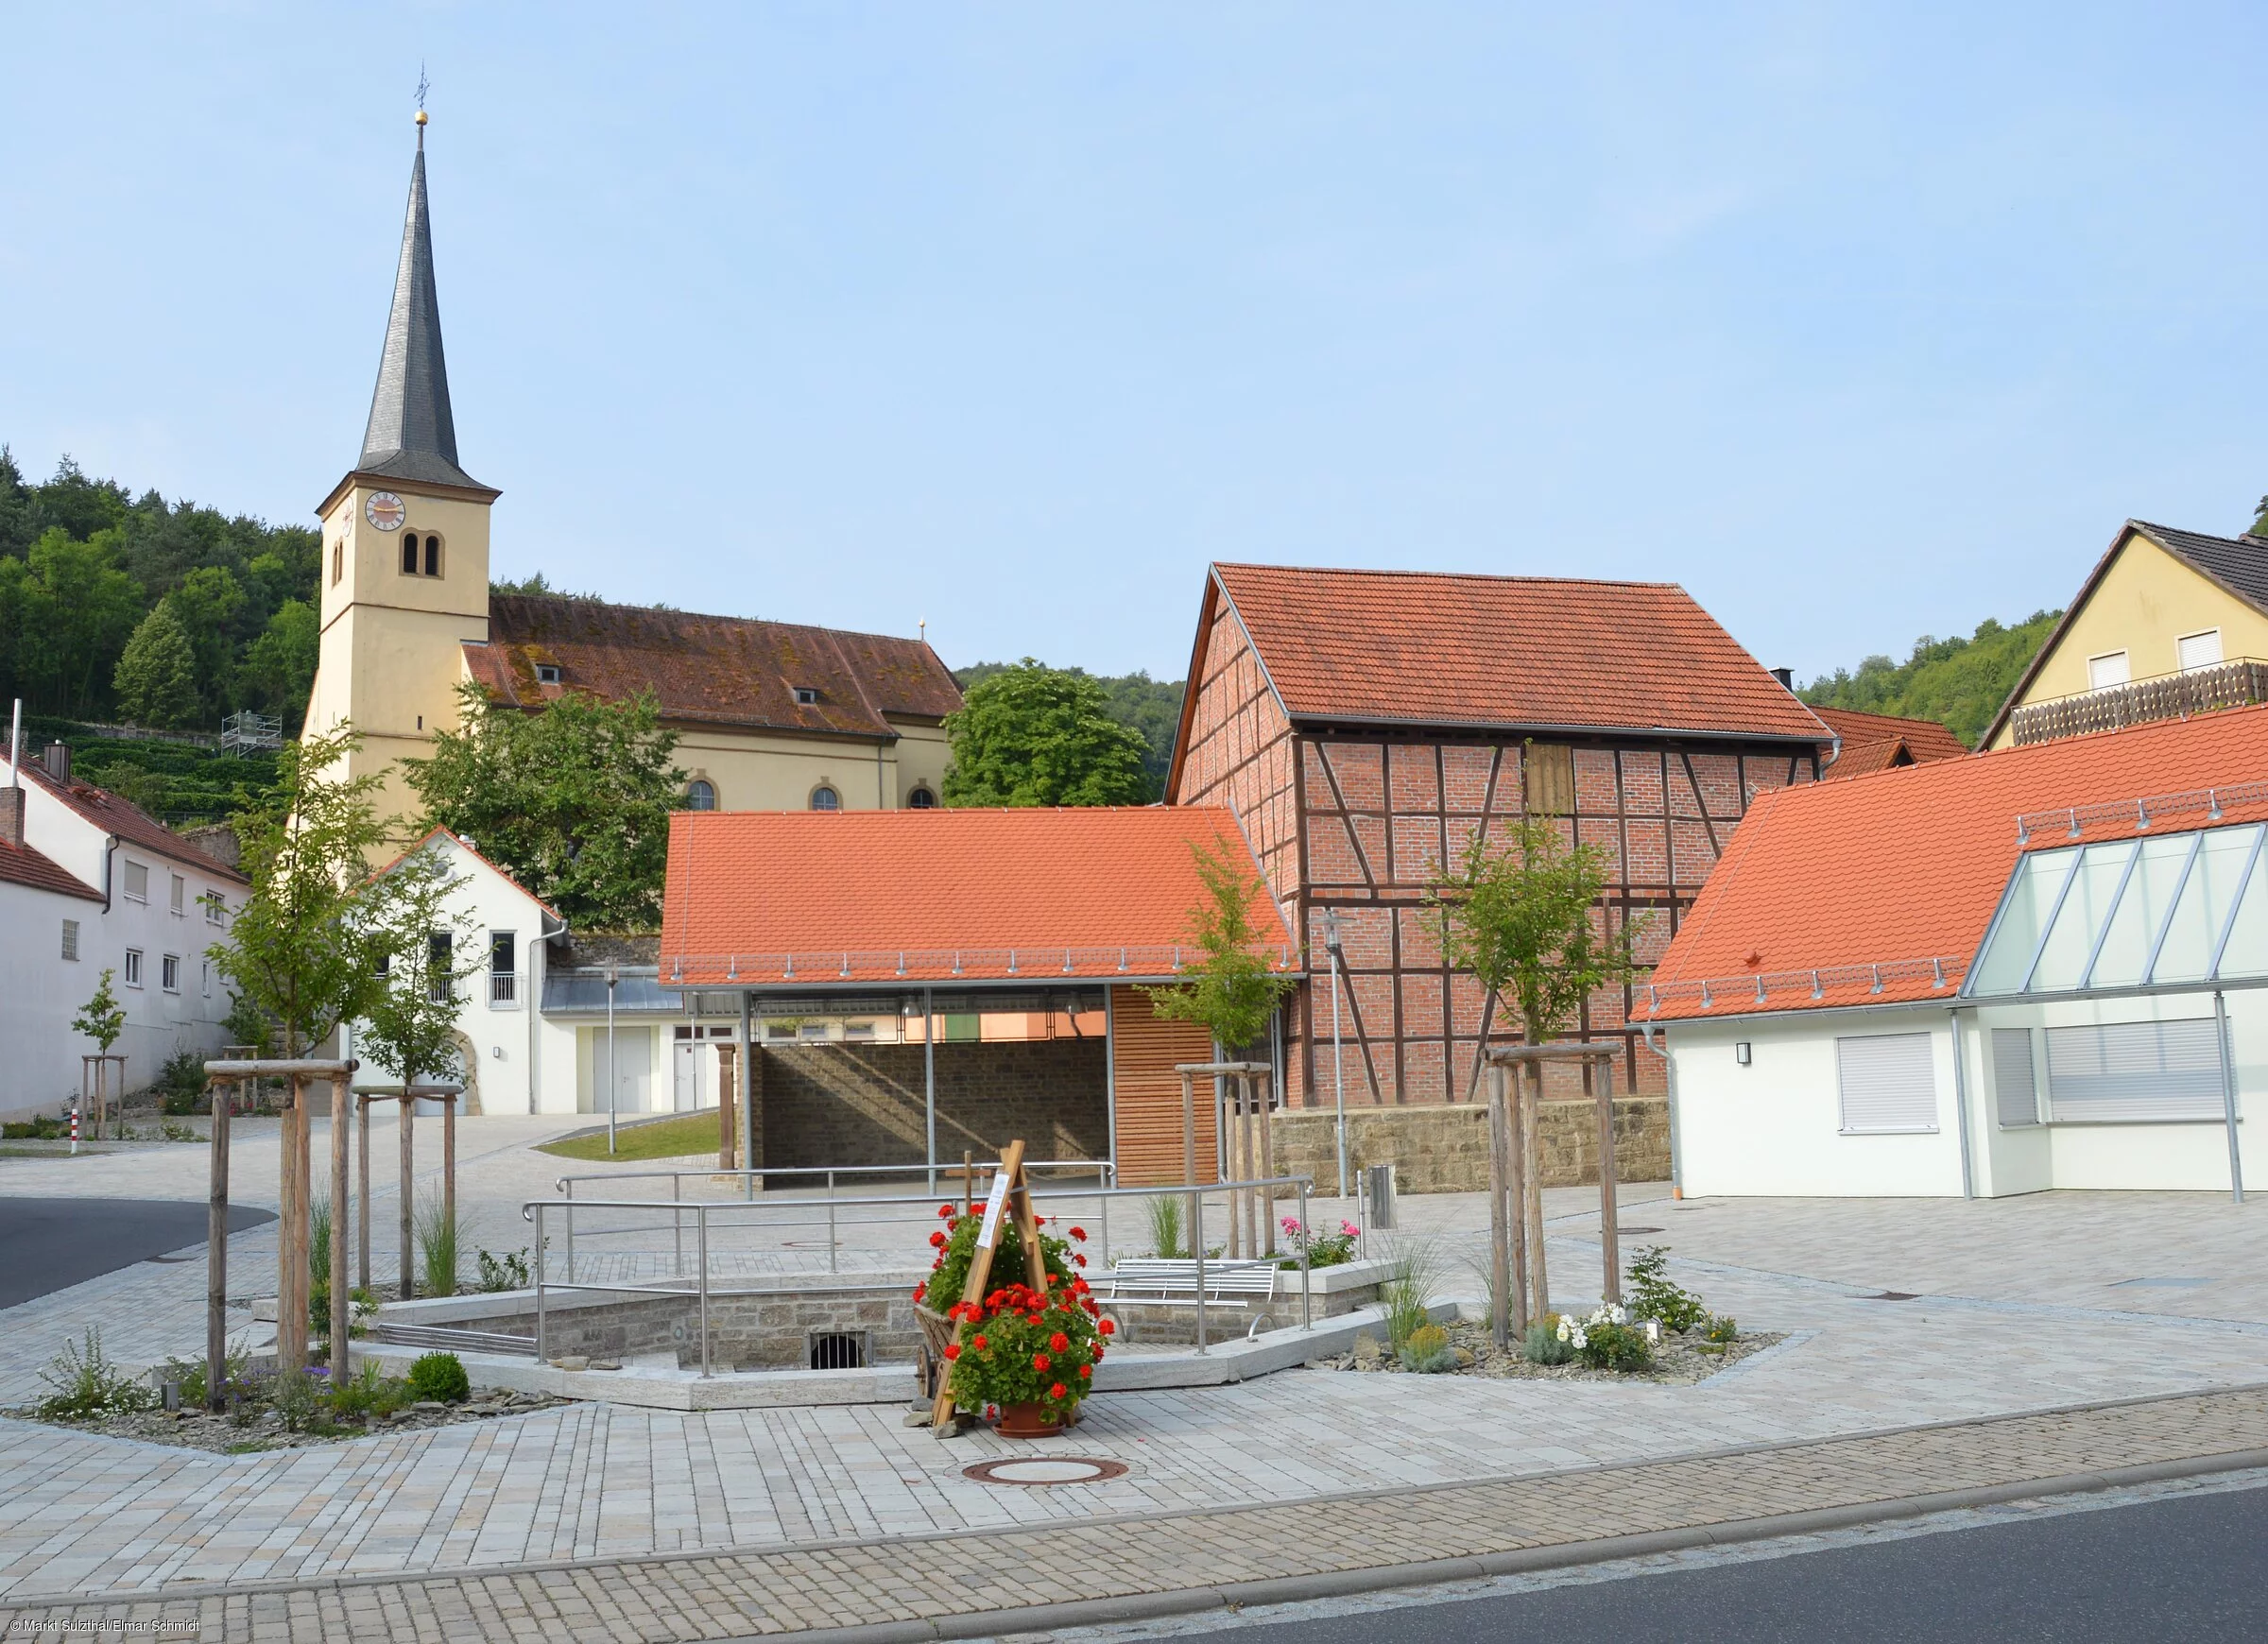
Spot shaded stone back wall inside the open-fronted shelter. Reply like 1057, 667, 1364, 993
758, 1038, 1111, 1168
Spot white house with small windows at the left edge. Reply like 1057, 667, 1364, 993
0, 744, 249, 1118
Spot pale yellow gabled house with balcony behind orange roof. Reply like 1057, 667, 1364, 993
1984, 520, 2268, 748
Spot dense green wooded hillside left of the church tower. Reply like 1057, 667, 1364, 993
0, 447, 322, 729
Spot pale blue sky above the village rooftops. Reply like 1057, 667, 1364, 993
0, 0, 2268, 678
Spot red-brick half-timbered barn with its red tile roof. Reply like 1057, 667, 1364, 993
1166, 565, 1832, 1106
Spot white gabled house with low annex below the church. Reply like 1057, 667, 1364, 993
342, 828, 737, 1116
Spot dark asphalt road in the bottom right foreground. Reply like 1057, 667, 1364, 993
1220, 1487, 2268, 1644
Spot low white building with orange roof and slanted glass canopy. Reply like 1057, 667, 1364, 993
1635, 708, 2268, 1197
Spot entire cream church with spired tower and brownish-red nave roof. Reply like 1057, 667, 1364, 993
306, 115, 962, 816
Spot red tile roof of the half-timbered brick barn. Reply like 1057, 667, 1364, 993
1213, 565, 1828, 742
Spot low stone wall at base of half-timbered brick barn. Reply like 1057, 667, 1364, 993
1272, 1095, 1669, 1192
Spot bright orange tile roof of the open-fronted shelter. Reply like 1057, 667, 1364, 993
662, 805, 1297, 986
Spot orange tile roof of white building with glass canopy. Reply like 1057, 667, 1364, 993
1635, 708, 2268, 1020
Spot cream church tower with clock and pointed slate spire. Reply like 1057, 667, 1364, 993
306, 109, 499, 816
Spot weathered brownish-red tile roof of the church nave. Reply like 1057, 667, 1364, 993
465, 594, 962, 737
